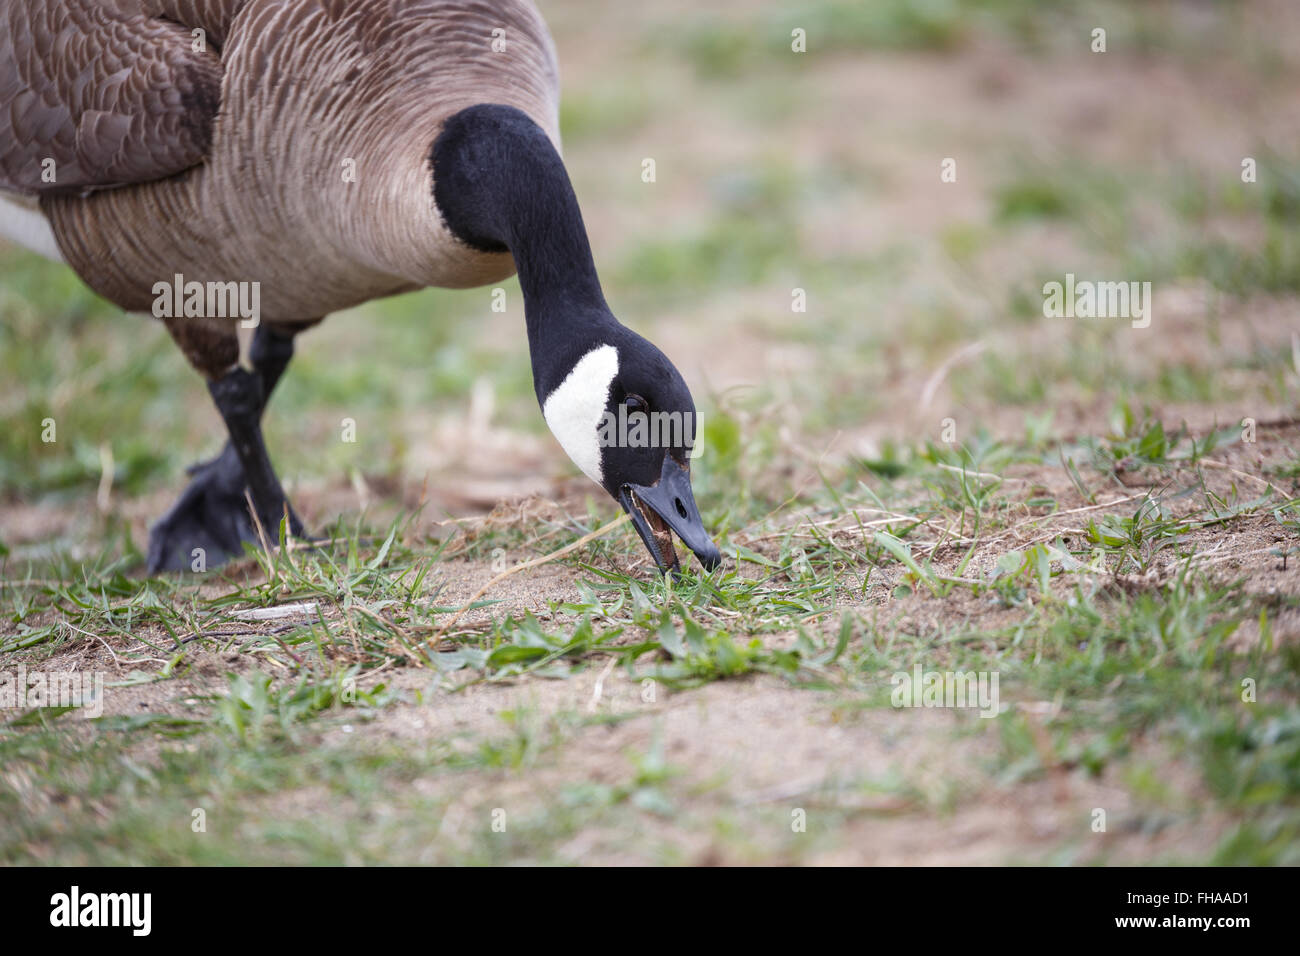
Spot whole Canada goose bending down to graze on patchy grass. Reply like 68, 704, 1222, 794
0, 0, 720, 571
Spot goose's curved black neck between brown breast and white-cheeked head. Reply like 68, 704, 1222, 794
433, 104, 612, 343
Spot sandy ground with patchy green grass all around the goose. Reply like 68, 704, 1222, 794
0, 0, 1300, 864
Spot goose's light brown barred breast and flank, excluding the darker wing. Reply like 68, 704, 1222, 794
16, 0, 559, 325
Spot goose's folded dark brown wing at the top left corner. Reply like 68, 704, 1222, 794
0, 0, 237, 194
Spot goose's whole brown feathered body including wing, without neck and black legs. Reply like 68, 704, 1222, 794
8, 0, 559, 377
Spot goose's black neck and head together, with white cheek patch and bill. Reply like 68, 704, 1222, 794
430, 104, 722, 572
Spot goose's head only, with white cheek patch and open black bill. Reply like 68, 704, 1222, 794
538, 325, 722, 571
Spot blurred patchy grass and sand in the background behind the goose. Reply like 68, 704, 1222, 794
0, 0, 1300, 544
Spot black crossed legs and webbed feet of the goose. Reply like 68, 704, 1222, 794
148, 324, 303, 574
